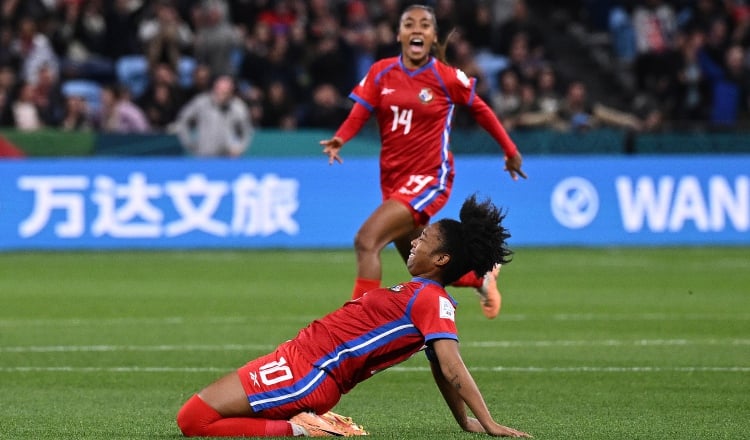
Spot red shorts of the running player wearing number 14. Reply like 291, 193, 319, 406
381, 173, 453, 226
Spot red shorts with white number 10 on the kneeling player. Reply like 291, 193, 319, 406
237, 342, 341, 420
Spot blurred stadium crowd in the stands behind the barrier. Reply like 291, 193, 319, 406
0, 0, 750, 138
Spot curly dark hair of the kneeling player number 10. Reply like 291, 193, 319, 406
436, 194, 513, 285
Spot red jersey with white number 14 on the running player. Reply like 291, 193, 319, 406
349, 57, 475, 199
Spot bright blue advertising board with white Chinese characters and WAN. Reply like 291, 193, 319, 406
0, 155, 750, 250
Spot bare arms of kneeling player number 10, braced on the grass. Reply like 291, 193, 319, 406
432, 339, 531, 438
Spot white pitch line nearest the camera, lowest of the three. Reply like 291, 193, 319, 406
0, 366, 750, 373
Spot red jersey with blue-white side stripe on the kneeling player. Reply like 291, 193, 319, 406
292, 278, 458, 393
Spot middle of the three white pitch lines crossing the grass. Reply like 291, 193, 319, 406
0, 339, 750, 353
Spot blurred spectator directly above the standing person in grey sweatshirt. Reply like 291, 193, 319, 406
193, 0, 242, 75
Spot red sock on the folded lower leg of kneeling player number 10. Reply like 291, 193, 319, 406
177, 394, 293, 437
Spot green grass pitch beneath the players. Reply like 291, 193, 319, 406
0, 247, 750, 440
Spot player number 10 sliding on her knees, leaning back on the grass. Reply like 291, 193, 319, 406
177, 196, 529, 437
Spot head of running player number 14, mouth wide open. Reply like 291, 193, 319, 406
398, 8, 437, 68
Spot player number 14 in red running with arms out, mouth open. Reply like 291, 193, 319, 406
320, 5, 526, 319
